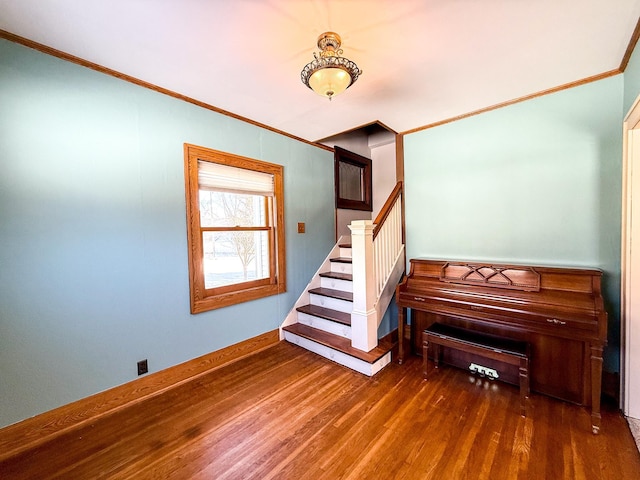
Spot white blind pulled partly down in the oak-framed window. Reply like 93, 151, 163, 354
198, 160, 274, 196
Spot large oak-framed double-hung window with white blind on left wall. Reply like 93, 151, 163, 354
185, 144, 286, 313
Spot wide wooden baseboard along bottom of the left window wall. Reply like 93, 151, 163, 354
0, 330, 280, 462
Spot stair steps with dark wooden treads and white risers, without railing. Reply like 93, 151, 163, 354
282, 243, 394, 376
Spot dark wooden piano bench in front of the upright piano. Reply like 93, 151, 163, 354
422, 323, 530, 417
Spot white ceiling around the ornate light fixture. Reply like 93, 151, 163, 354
0, 0, 640, 141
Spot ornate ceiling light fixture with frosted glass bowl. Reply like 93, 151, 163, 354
300, 32, 362, 100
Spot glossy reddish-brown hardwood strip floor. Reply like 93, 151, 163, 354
0, 343, 640, 480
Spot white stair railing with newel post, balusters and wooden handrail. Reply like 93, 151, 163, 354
349, 182, 405, 352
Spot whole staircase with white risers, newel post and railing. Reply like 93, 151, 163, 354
280, 183, 405, 376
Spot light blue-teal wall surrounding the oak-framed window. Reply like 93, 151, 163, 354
0, 40, 335, 426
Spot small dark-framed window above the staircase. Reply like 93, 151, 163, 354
334, 146, 373, 208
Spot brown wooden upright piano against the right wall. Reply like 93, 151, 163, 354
396, 259, 607, 433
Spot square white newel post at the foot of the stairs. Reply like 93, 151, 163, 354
349, 220, 378, 352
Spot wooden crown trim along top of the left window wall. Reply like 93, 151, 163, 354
0, 29, 333, 152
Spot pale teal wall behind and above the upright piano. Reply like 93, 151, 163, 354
404, 75, 623, 372
